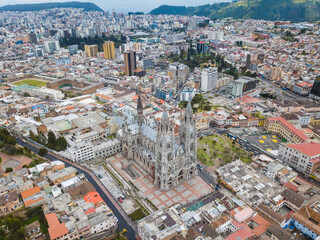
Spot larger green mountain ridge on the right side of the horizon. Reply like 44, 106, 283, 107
150, 0, 320, 22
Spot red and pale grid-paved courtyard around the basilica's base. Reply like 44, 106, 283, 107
108, 154, 213, 209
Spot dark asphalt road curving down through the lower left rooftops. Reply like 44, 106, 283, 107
16, 138, 136, 240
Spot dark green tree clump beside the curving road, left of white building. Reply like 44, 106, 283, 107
30, 130, 68, 151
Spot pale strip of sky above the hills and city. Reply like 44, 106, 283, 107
0, 0, 230, 13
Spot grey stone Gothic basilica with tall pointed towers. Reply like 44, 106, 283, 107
121, 96, 197, 191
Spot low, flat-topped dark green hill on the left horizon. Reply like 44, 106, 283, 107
0, 2, 103, 12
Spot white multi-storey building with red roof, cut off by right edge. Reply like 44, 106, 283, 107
278, 143, 320, 175
